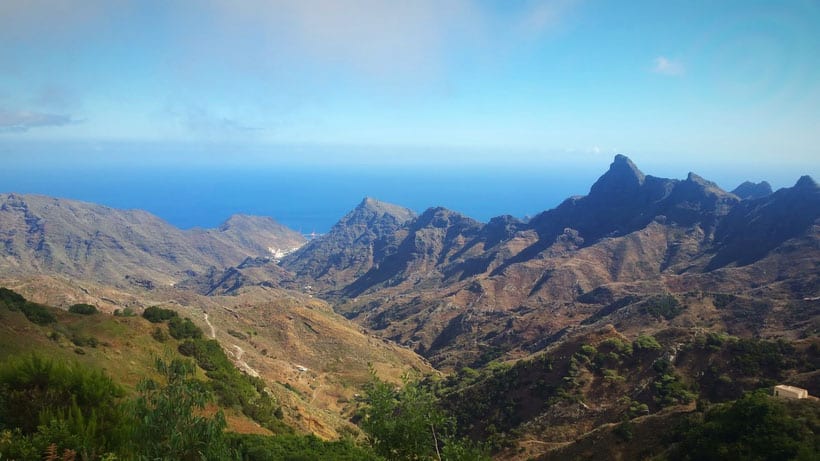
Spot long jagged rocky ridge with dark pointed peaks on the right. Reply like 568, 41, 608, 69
283, 155, 820, 368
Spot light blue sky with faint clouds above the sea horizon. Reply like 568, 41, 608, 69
0, 0, 820, 176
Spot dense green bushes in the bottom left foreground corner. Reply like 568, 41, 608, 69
0, 355, 381, 461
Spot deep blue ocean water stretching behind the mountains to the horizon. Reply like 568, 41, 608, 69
0, 164, 605, 233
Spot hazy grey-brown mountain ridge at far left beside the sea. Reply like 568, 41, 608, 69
0, 194, 304, 289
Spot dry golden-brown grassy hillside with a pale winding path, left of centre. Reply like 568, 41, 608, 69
0, 277, 432, 439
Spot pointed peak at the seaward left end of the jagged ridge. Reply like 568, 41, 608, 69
282, 197, 415, 290
